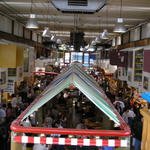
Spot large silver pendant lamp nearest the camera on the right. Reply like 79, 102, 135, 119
114, 0, 126, 33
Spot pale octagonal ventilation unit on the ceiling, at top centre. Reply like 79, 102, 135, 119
50, 0, 107, 13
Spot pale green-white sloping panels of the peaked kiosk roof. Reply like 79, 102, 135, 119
22, 63, 120, 125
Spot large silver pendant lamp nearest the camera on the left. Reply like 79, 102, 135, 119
26, 0, 38, 29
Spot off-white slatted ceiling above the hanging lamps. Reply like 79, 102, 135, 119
0, 0, 150, 42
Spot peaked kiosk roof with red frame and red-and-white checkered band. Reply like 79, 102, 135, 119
11, 63, 130, 147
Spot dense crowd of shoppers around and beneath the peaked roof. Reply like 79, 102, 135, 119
0, 65, 142, 150
